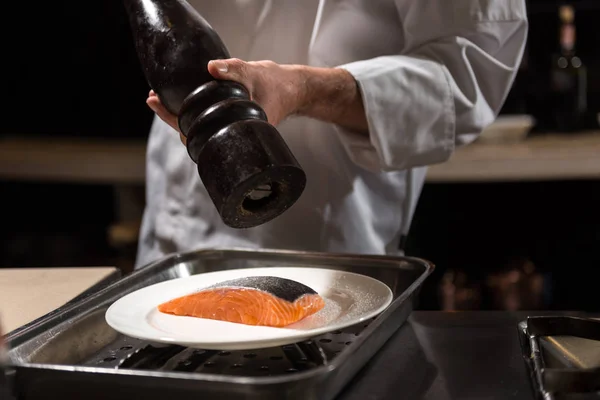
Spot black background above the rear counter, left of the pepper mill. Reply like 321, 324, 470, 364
0, 0, 152, 138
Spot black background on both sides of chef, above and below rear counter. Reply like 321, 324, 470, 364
0, 0, 600, 311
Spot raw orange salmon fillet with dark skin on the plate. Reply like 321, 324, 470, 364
158, 276, 325, 327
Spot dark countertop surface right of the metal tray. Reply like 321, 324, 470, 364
339, 311, 534, 400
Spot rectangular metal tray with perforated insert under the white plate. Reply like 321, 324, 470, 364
4, 249, 434, 400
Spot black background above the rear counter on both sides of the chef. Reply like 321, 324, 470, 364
5, 0, 600, 138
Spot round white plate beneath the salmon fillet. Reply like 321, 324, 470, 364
106, 267, 393, 350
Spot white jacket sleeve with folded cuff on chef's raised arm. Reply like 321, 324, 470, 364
336, 0, 528, 170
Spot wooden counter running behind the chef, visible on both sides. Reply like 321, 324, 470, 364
0, 132, 600, 185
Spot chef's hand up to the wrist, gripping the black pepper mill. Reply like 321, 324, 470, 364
146, 59, 303, 144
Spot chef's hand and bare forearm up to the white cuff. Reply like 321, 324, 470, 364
146, 58, 368, 144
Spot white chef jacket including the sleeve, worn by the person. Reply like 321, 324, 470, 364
136, 0, 528, 268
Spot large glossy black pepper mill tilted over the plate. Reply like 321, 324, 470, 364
124, 0, 306, 228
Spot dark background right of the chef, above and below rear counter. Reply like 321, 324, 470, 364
406, 0, 600, 312
